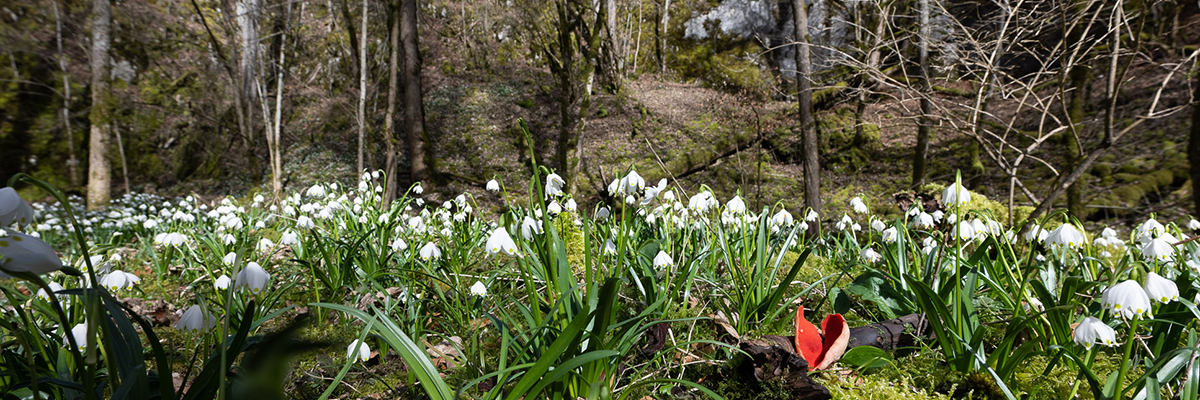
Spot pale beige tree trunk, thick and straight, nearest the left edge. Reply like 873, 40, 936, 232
88, 0, 113, 209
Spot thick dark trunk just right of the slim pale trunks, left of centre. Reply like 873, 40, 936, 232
400, 0, 428, 181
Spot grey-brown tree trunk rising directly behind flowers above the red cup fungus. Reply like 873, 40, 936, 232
792, 0, 821, 218
